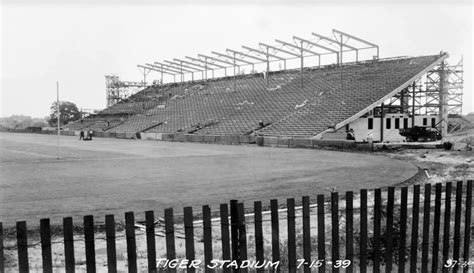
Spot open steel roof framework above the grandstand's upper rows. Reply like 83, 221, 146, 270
138, 29, 379, 85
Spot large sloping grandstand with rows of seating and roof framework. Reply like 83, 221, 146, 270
67, 29, 464, 141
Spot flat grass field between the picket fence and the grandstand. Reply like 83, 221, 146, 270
0, 133, 417, 226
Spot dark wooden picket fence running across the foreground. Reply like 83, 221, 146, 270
0, 180, 474, 272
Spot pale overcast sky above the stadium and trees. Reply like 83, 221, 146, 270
0, 0, 474, 117
